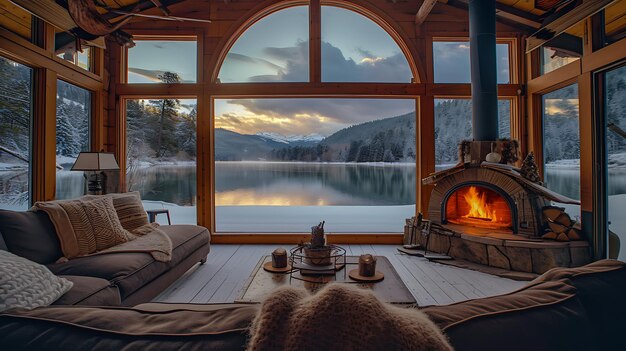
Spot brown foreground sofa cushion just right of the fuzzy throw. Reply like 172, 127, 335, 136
422, 280, 597, 351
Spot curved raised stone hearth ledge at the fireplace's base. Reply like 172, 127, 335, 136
418, 224, 591, 274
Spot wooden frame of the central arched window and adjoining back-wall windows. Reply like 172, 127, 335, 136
116, 4, 525, 244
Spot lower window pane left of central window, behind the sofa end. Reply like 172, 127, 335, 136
126, 98, 197, 224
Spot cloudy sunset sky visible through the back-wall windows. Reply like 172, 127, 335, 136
123, 6, 509, 136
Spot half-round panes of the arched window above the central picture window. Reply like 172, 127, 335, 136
218, 6, 413, 83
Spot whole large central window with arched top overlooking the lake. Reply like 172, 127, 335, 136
212, 5, 417, 233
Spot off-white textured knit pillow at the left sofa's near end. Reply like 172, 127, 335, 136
0, 250, 73, 312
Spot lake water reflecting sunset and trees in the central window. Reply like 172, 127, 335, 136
215, 162, 416, 206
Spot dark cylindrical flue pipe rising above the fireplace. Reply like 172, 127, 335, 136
469, 0, 498, 141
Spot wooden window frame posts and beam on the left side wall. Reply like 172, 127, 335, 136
0, 20, 104, 203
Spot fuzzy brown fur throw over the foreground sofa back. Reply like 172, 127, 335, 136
248, 284, 452, 351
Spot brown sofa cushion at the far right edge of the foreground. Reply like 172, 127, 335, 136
532, 260, 626, 350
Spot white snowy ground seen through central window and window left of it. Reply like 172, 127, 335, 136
143, 200, 415, 233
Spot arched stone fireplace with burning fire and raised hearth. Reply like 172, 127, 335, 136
420, 141, 590, 276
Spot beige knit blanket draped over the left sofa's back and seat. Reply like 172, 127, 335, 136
34, 197, 172, 262
